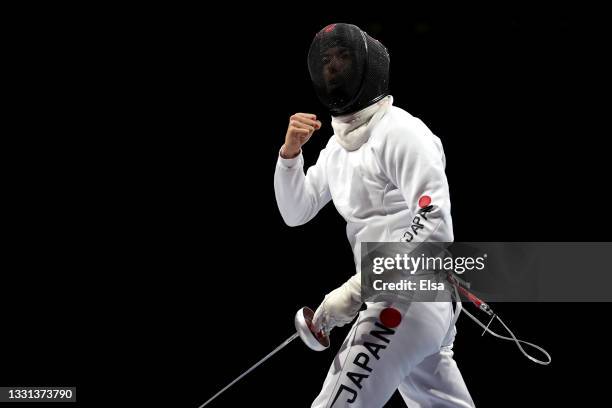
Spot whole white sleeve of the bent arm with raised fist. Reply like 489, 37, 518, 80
274, 143, 331, 227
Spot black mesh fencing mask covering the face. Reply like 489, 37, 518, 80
308, 23, 389, 116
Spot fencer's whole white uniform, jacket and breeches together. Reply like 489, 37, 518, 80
274, 96, 474, 408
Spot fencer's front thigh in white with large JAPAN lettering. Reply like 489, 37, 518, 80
312, 302, 452, 408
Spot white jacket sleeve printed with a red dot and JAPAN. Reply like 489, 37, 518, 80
376, 121, 454, 242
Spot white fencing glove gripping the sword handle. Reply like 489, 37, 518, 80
312, 274, 363, 334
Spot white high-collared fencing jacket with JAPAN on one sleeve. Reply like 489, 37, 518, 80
274, 97, 453, 302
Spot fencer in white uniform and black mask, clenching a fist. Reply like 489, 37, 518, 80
274, 23, 474, 408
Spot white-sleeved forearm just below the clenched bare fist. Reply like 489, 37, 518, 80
274, 152, 326, 227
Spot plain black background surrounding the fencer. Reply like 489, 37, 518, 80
0, 3, 612, 407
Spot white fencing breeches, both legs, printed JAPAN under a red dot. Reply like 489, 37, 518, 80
312, 302, 474, 408
